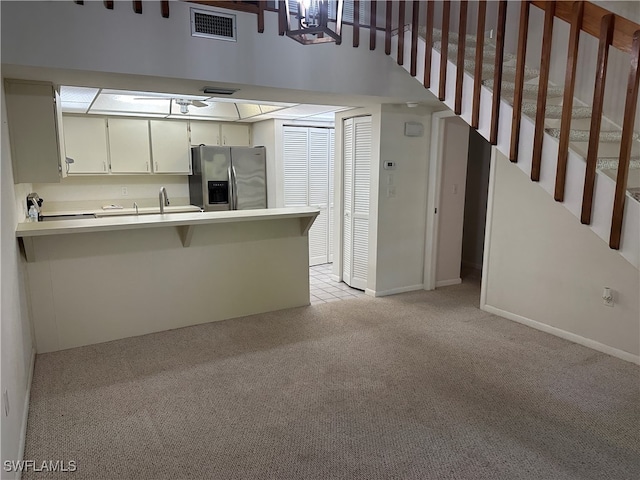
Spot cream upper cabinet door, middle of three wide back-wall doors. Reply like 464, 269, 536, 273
109, 118, 151, 173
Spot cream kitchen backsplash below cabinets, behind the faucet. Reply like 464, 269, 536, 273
33, 175, 189, 214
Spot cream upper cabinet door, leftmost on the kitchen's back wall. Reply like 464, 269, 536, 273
62, 115, 109, 175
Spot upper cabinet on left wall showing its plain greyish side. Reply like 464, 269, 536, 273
5, 80, 62, 183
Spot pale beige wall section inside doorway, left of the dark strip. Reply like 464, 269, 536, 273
436, 117, 469, 286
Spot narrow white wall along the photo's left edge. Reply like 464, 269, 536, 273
0, 79, 34, 478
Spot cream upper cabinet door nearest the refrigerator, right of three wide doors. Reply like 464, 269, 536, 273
149, 120, 191, 174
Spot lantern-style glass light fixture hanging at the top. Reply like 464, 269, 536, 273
285, 0, 343, 45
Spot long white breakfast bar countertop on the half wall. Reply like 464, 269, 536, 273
16, 207, 320, 238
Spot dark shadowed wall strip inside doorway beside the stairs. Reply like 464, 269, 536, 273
462, 128, 491, 269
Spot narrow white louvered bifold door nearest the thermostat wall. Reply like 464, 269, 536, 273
342, 116, 371, 290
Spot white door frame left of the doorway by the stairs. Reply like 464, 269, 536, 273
423, 110, 457, 290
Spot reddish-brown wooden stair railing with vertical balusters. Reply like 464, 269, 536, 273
75, 0, 640, 249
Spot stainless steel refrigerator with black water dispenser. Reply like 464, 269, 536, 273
189, 145, 267, 211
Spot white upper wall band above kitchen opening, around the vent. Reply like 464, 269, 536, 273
1, 1, 430, 101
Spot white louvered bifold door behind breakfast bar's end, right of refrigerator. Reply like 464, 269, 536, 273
283, 126, 334, 265
